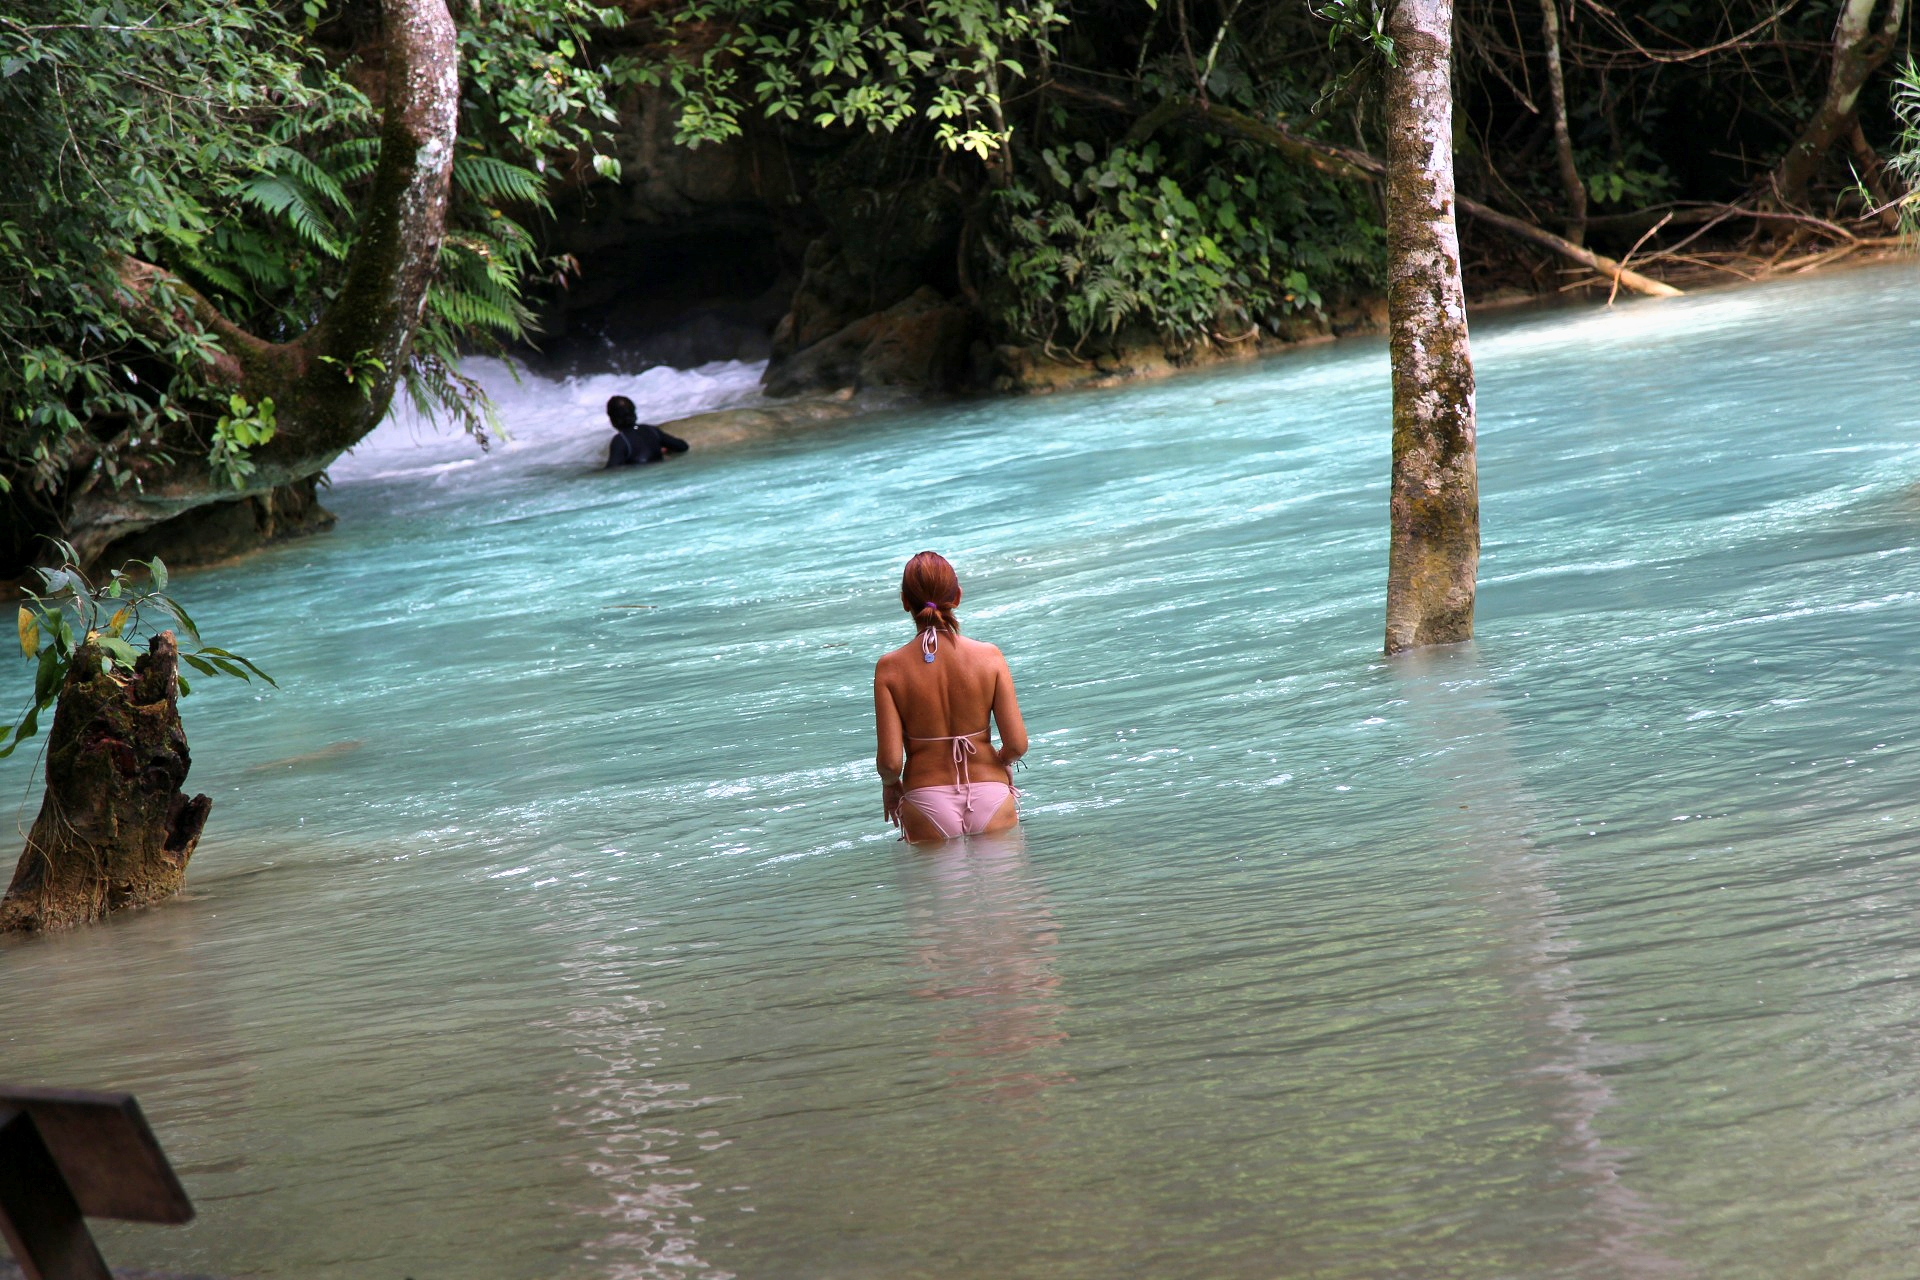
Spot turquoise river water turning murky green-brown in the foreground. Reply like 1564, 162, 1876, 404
0, 269, 1920, 1280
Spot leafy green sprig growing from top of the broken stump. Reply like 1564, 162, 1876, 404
0, 541, 275, 756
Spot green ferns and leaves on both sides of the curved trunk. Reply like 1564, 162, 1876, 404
0, 0, 639, 514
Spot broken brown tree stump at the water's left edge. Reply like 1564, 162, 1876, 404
0, 631, 213, 933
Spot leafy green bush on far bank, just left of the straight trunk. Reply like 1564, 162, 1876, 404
998, 140, 1382, 349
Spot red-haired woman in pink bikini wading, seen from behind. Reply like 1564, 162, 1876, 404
874, 551, 1027, 844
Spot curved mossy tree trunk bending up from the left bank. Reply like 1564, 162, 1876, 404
67, 0, 461, 558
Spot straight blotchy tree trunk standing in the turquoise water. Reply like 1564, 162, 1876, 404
1386, 0, 1480, 652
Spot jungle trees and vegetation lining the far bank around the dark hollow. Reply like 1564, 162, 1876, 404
0, 0, 1920, 574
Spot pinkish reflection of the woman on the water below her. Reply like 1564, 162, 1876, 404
897, 827, 1073, 1102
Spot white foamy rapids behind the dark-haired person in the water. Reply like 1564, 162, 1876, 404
328, 359, 766, 487
